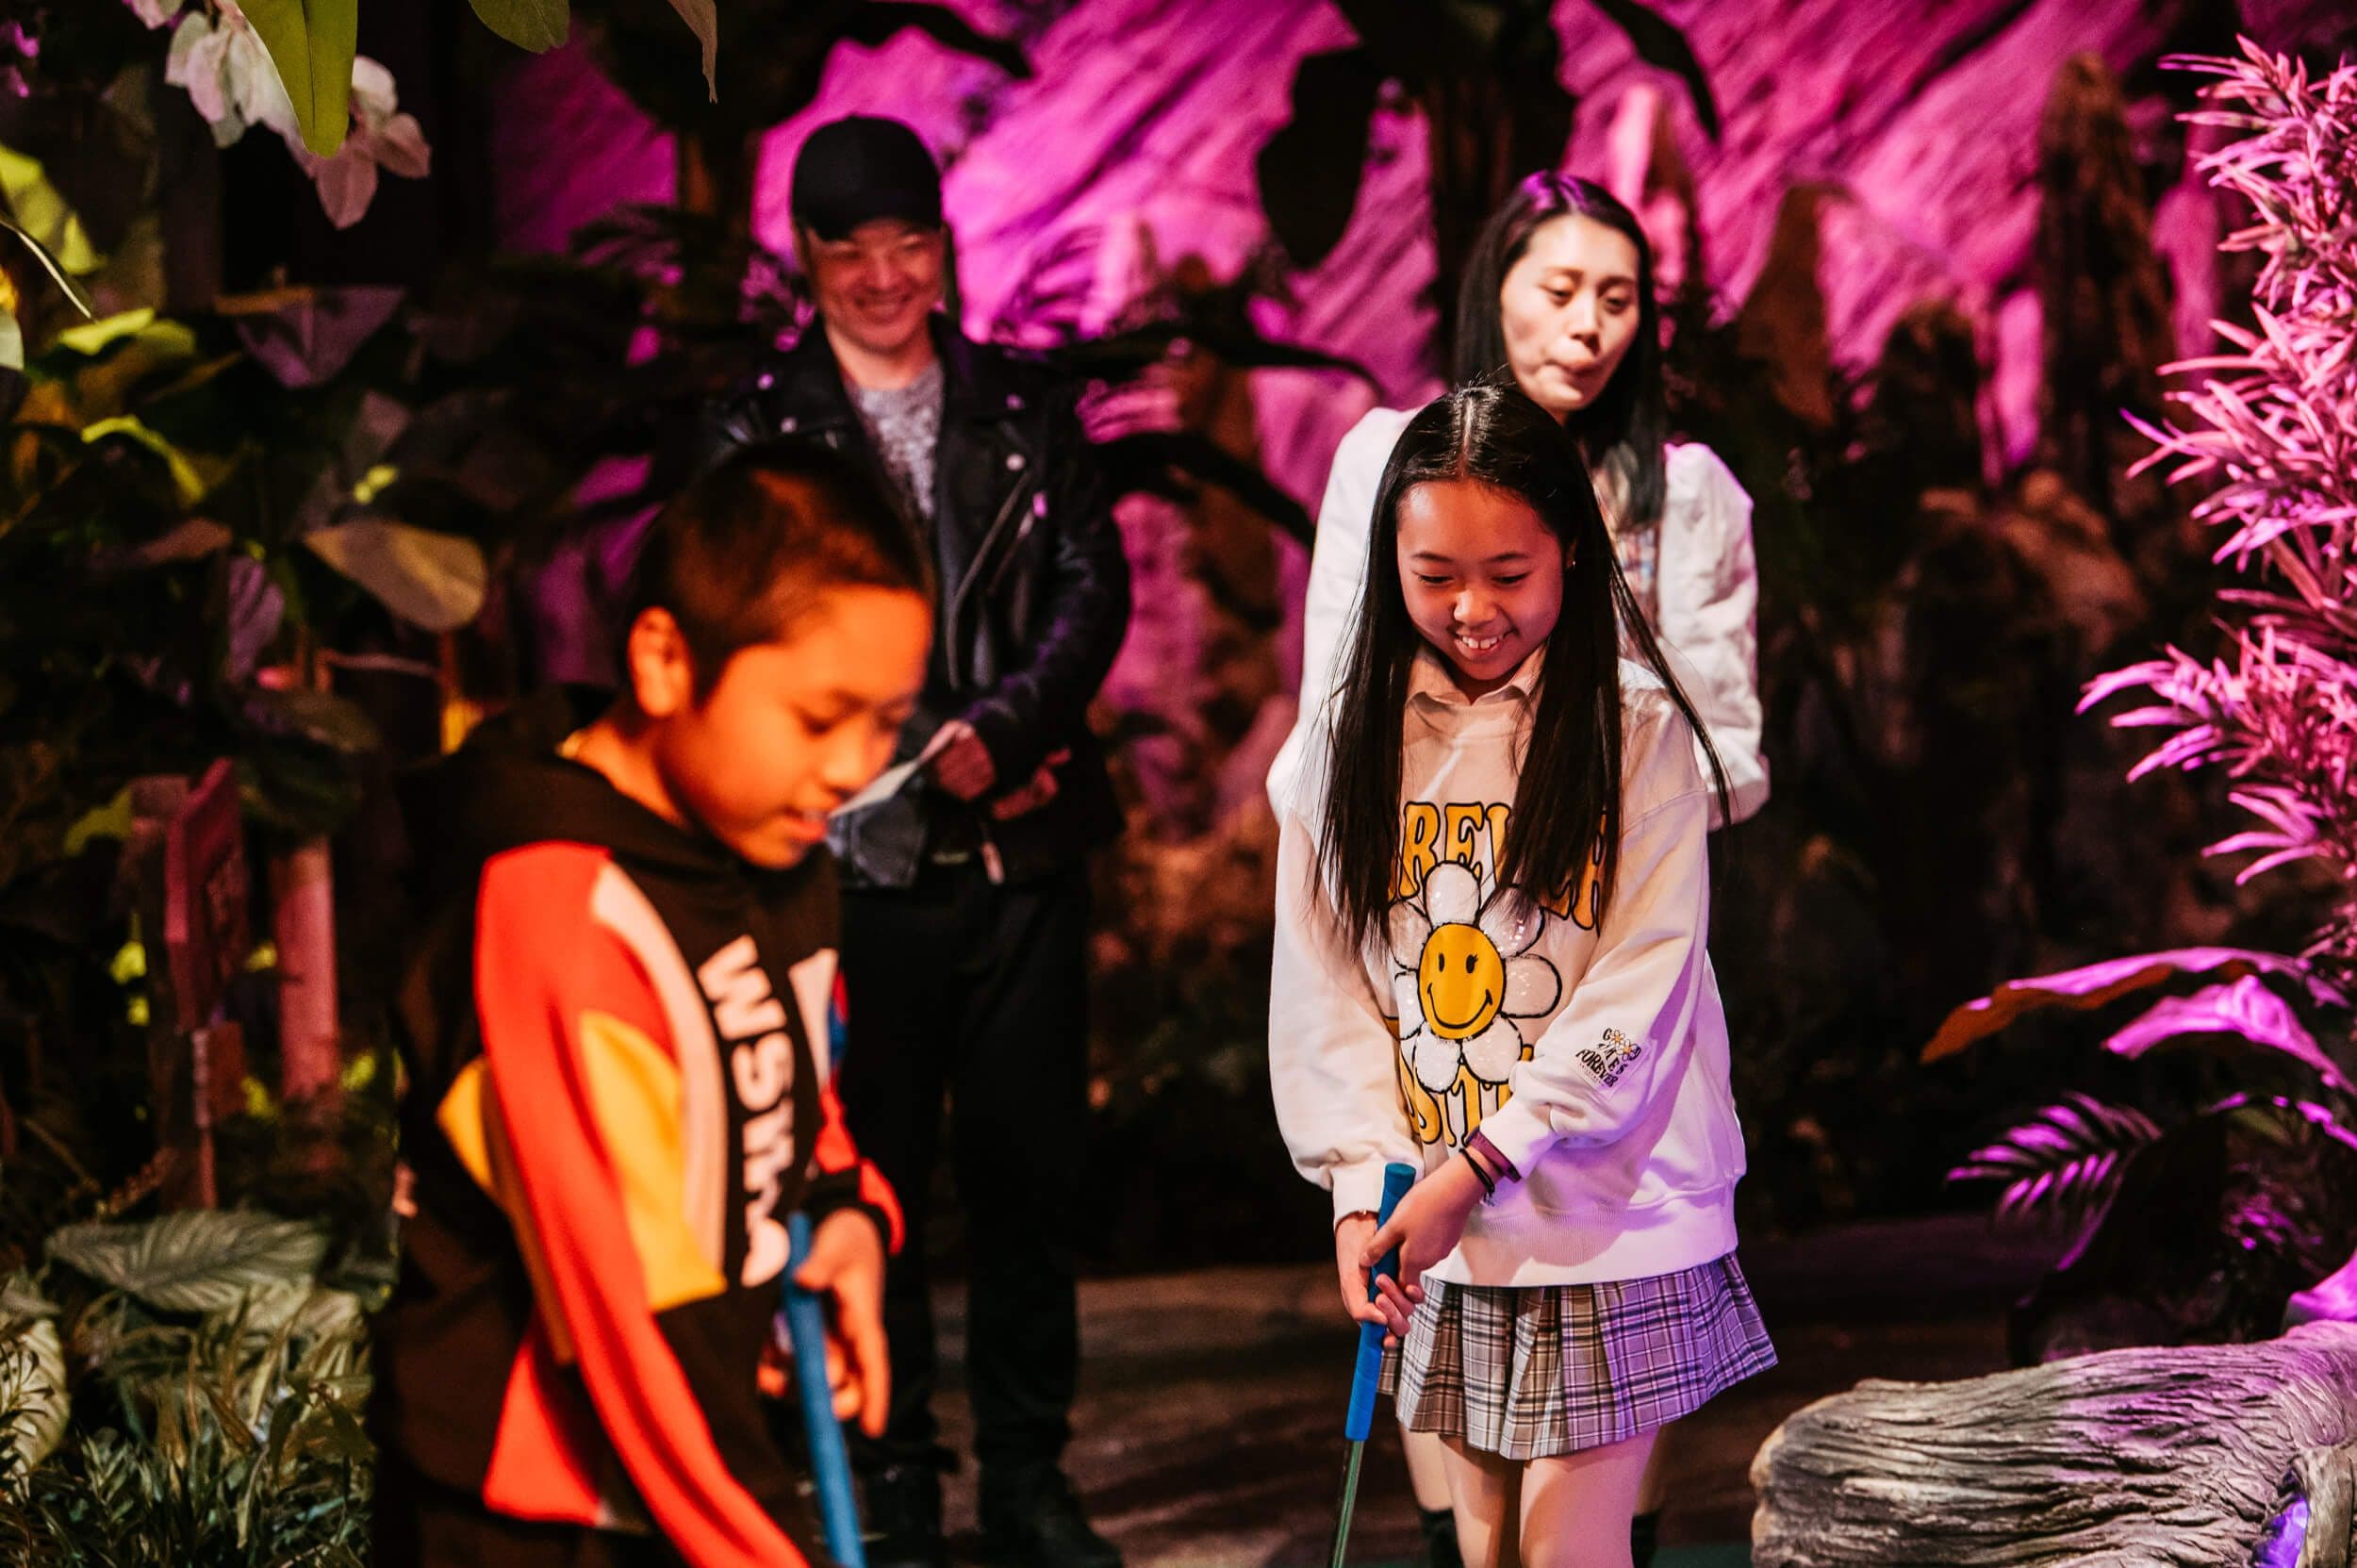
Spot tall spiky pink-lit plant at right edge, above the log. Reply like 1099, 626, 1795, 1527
2082, 42, 2357, 983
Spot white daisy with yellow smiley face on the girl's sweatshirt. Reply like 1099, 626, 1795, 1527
1391, 861, 1563, 1113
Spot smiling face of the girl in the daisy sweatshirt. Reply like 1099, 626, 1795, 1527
1398, 479, 1565, 698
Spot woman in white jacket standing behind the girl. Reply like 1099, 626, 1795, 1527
1268, 174, 1768, 1568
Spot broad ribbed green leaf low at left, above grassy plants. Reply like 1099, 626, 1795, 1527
50, 1210, 328, 1313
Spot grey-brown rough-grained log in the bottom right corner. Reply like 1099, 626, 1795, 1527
1752, 1323, 2357, 1568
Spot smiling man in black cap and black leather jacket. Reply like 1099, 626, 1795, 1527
707, 118, 1129, 1568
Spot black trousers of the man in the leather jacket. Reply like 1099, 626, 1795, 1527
842, 863, 1089, 1471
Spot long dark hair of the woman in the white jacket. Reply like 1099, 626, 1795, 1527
1452, 173, 1669, 528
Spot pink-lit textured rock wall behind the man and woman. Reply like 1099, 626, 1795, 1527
495, 0, 2346, 514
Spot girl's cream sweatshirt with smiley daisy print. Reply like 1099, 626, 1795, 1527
1268, 649, 1744, 1285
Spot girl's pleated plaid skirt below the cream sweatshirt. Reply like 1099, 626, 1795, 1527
1384, 1252, 1775, 1461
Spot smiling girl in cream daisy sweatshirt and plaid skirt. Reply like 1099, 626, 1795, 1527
1271, 385, 1775, 1568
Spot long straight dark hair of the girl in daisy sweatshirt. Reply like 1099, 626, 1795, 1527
1318, 377, 1728, 950
